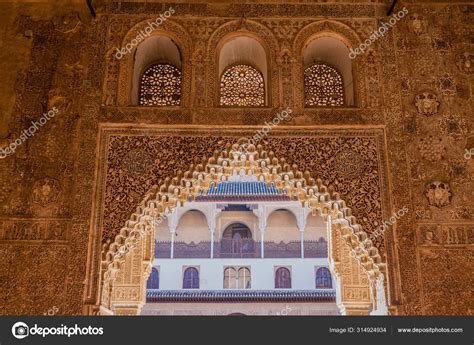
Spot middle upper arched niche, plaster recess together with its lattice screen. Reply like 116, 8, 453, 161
218, 35, 269, 107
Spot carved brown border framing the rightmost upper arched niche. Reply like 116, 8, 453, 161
293, 20, 367, 109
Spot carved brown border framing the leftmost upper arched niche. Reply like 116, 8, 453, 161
117, 18, 192, 107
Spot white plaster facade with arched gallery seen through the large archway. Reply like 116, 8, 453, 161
142, 191, 339, 315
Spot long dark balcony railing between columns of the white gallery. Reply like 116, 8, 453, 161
155, 239, 328, 259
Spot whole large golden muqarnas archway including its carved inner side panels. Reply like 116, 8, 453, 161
99, 144, 388, 315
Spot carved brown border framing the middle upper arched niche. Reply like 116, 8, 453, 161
206, 19, 279, 107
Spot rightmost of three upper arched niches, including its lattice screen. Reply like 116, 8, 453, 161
303, 35, 355, 106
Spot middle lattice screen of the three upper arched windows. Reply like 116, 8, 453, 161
220, 65, 265, 107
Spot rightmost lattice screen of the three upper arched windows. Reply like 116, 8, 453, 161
304, 64, 344, 107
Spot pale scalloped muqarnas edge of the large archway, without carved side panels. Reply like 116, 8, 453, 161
101, 144, 387, 310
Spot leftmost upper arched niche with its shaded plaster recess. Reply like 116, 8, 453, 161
131, 35, 182, 105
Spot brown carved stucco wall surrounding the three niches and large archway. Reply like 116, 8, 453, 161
0, 2, 474, 314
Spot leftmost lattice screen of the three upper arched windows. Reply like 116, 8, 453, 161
139, 63, 181, 106
